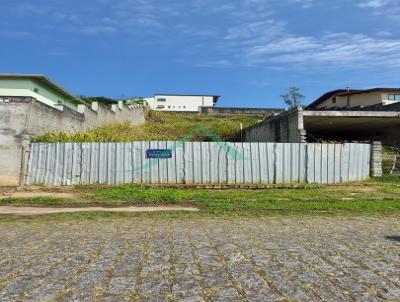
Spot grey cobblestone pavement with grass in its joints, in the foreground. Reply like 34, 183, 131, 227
0, 216, 400, 301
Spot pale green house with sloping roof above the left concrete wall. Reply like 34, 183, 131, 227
0, 74, 85, 111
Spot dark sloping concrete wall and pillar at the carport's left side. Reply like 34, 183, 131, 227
236, 108, 306, 143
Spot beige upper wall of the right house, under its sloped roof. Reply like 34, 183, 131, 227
317, 91, 400, 109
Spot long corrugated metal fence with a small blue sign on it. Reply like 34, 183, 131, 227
26, 141, 371, 185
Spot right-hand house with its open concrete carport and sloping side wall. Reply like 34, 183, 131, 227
237, 88, 400, 145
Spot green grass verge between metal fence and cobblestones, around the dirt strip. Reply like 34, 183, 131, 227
0, 176, 400, 217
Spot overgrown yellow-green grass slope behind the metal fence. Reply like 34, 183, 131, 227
34, 110, 262, 143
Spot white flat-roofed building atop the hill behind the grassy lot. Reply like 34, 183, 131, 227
144, 93, 220, 112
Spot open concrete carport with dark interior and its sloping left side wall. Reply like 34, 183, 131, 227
237, 106, 400, 146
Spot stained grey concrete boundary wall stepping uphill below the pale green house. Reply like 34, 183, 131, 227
0, 96, 144, 186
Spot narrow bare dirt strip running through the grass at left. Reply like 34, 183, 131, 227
0, 206, 199, 215
